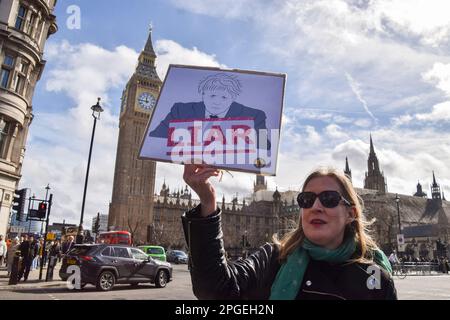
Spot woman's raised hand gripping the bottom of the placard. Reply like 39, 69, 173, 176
183, 164, 220, 217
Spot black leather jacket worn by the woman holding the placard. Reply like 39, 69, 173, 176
182, 206, 397, 300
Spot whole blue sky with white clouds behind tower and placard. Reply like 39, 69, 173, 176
21, 0, 450, 227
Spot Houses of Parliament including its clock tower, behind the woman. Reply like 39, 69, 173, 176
108, 31, 450, 258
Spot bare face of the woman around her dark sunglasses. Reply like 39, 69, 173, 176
301, 176, 355, 249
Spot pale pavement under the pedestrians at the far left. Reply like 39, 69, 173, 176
0, 264, 66, 290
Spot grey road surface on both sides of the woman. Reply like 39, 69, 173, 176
0, 264, 450, 300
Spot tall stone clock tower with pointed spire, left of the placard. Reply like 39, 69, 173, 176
108, 29, 162, 244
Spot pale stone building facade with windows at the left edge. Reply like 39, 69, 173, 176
0, 0, 58, 235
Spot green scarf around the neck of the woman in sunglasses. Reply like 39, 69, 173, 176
270, 237, 392, 300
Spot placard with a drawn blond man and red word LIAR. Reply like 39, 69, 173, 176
139, 65, 286, 175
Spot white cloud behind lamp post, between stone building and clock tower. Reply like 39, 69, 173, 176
21, 41, 137, 227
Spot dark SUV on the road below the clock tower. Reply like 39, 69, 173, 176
59, 244, 172, 291
